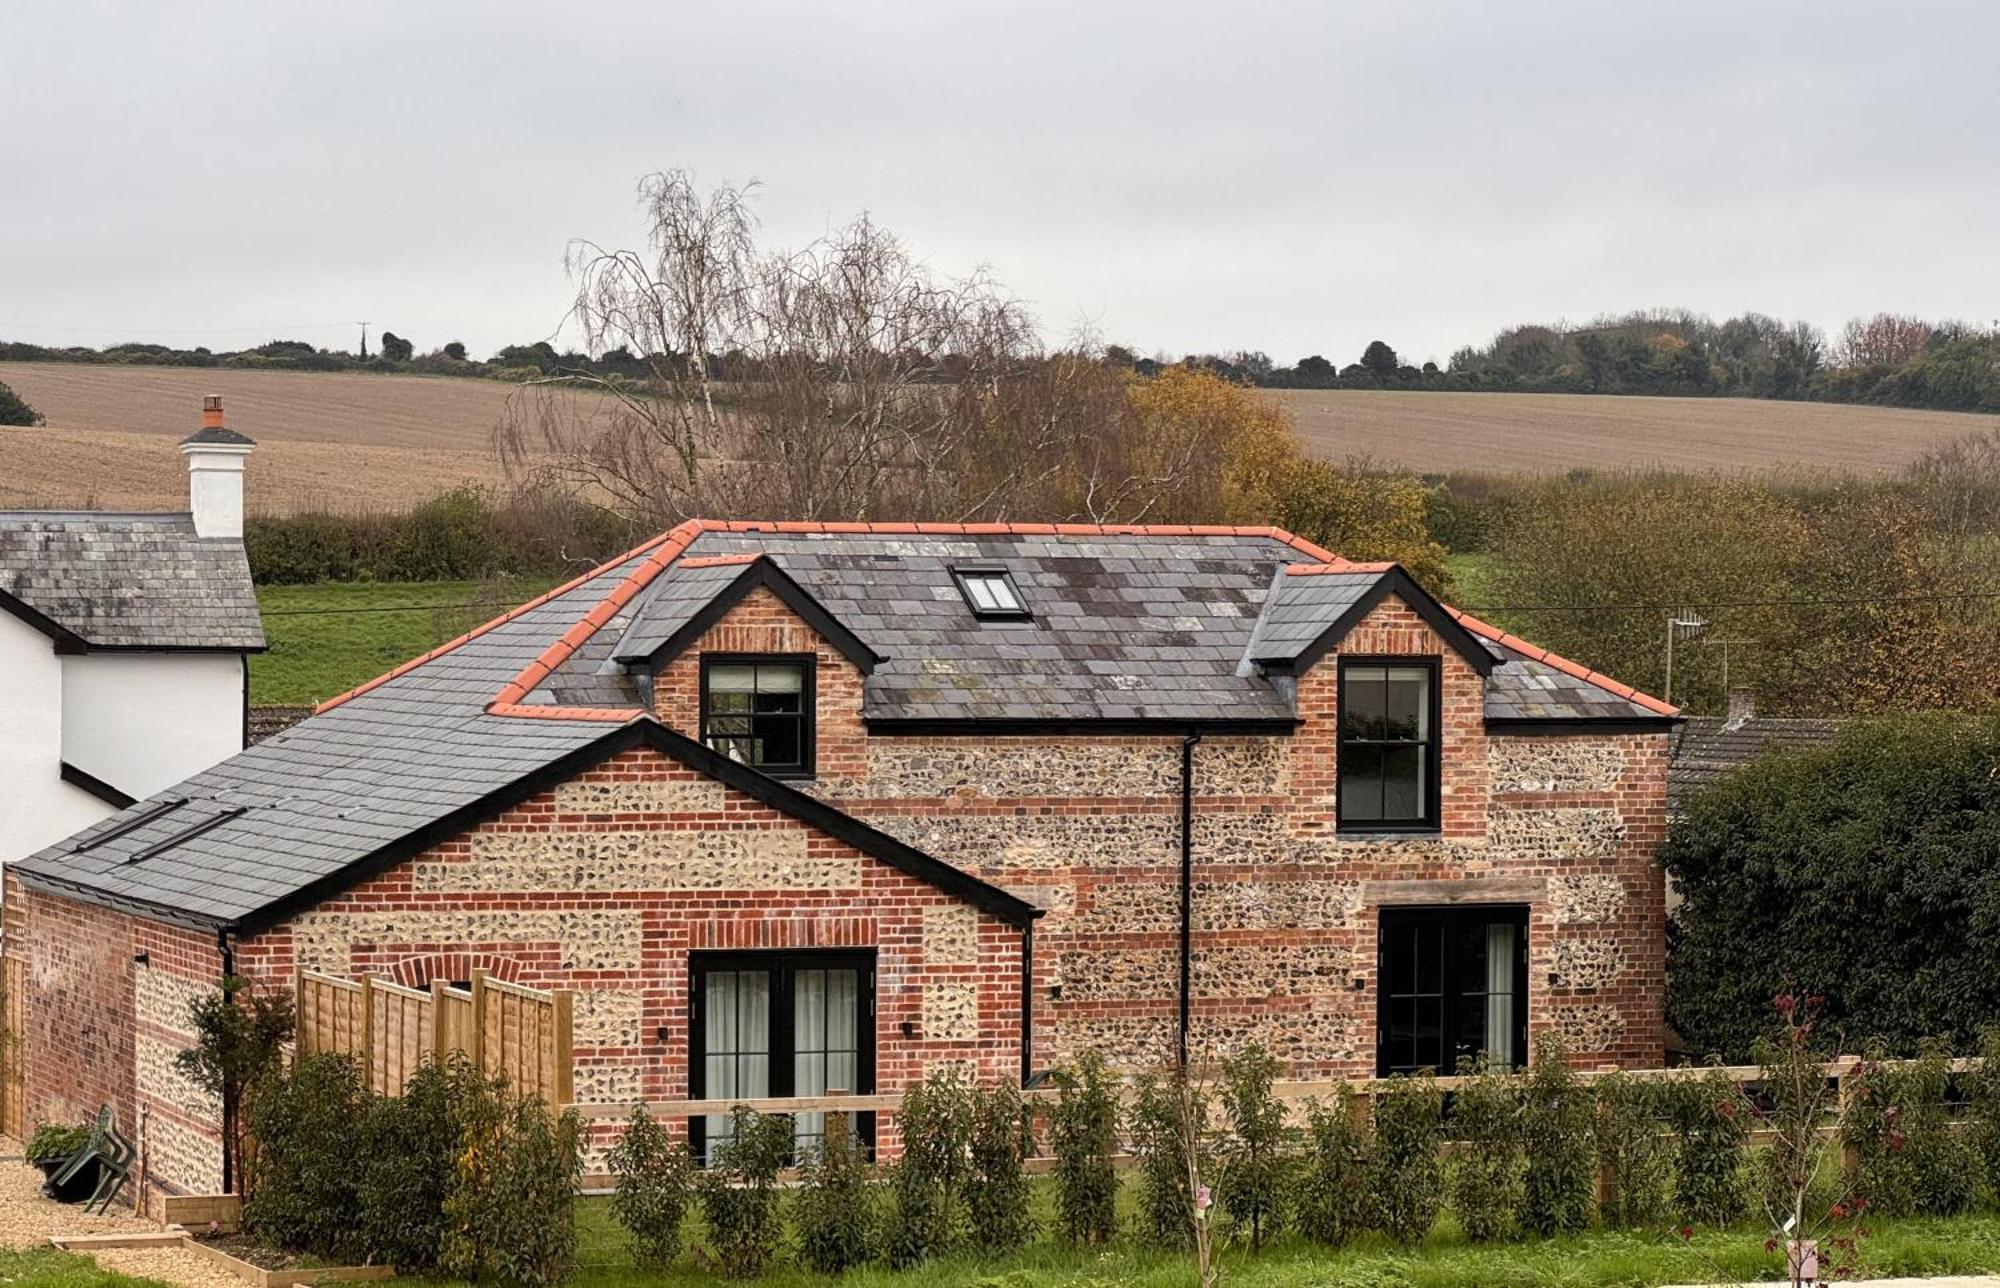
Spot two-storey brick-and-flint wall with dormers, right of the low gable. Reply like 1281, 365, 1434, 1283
656, 596, 1666, 1076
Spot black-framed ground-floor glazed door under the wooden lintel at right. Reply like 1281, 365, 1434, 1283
1376, 904, 1528, 1078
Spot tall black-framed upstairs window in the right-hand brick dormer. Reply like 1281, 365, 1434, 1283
1336, 658, 1438, 832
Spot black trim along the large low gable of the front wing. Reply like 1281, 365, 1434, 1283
234, 716, 1040, 934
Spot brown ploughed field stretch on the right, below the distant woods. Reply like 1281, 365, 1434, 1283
1272, 392, 2000, 474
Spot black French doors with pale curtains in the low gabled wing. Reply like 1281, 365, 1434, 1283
688, 950, 874, 1158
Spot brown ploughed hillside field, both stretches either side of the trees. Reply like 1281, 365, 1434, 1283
0, 362, 2000, 514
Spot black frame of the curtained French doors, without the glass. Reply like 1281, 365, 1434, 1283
688, 948, 876, 1158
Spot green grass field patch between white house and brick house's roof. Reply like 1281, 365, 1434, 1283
250, 580, 554, 706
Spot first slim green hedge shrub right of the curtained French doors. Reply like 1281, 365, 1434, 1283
884, 1070, 972, 1268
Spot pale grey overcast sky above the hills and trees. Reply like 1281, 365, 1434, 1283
0, 0, 2000, 362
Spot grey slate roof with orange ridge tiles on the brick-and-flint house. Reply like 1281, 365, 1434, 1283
14, 524, 1672, 928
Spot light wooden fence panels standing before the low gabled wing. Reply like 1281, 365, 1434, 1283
296, 970, 576, 1106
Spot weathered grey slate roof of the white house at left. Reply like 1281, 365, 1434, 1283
0, 510, 264, 650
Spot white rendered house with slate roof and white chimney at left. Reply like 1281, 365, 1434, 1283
0, 398, 264, 862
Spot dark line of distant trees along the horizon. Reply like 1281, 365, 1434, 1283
0, 310, 2000, 412
